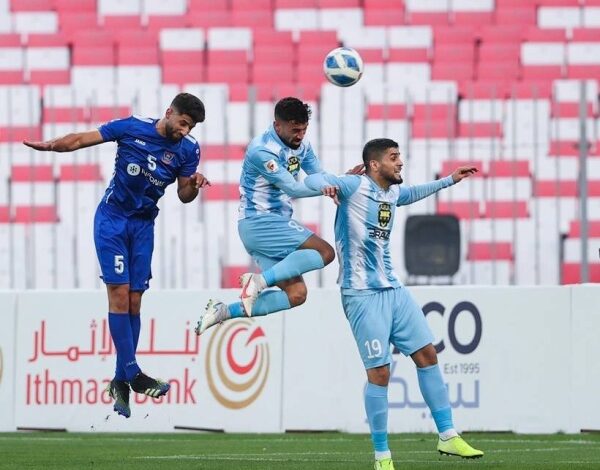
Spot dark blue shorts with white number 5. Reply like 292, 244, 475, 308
94, 204, 154, 291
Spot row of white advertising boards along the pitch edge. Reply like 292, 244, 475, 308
0, 285, 600, 433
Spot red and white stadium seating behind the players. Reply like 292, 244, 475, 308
0, 0, 600, 288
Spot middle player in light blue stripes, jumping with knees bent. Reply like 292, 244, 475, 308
196, 97, 342, 334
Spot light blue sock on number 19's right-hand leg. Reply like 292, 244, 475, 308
417, 364, 454, 433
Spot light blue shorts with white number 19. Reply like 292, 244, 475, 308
342, 287, 433, 369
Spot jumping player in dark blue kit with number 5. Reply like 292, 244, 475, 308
23, 93, 210, 418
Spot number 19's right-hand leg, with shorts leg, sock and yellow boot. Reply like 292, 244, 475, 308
392, 288, 483, 457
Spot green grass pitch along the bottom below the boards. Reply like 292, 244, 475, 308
0, 432, 600, 470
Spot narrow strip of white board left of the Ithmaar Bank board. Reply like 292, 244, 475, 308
0, 292, 17, 431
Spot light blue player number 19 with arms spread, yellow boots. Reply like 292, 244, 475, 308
305, 139, 483, 470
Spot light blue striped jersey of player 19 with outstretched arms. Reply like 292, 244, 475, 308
305, 173, 454, 295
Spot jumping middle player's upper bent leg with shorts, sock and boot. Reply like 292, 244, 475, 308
238, 216, 335, 316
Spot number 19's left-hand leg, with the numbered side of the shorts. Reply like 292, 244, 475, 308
342, 291, 394, 470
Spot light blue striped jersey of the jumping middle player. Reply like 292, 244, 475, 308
239, 125, 321, 219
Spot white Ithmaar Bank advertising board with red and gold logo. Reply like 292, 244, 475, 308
16, 291, 282, 432
